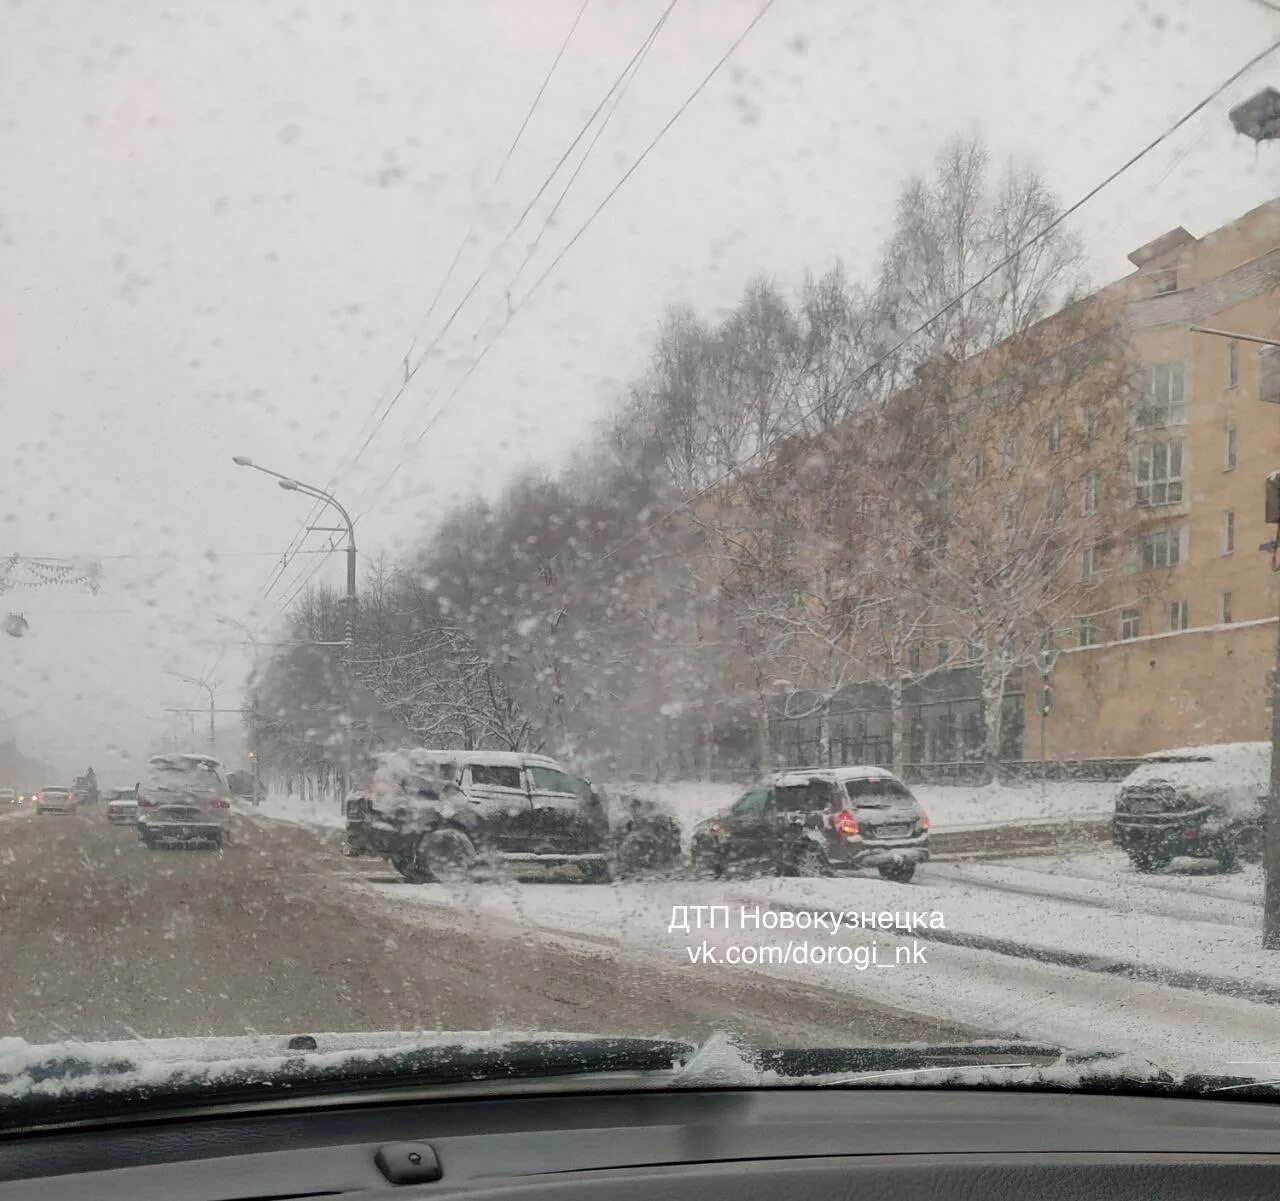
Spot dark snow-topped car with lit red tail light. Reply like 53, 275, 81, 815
690, 767, 929, 883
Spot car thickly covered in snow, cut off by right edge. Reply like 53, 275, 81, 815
1111, 743, 1271, 872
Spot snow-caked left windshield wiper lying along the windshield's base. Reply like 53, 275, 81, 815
0, 1035, 696, 1129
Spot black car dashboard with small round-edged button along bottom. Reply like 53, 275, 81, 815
0, 1082, 1280, 1201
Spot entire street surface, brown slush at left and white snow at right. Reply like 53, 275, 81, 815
0, 793, 1280, 1065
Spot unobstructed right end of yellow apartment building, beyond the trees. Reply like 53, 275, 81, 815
1025, 198, 1280, 758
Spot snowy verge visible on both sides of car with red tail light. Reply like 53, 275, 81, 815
605, 780, 1119, 845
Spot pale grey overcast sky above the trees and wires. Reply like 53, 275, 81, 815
0, 0, 1280, 784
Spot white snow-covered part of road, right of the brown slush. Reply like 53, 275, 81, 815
357, 851, 1280, 1068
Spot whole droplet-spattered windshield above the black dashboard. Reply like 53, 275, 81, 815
0, 0, 1280, 1134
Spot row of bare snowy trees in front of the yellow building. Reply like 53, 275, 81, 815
255, 141, 1133, 775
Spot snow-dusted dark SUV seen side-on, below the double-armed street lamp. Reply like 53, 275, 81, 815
344, 749, 609, 883
